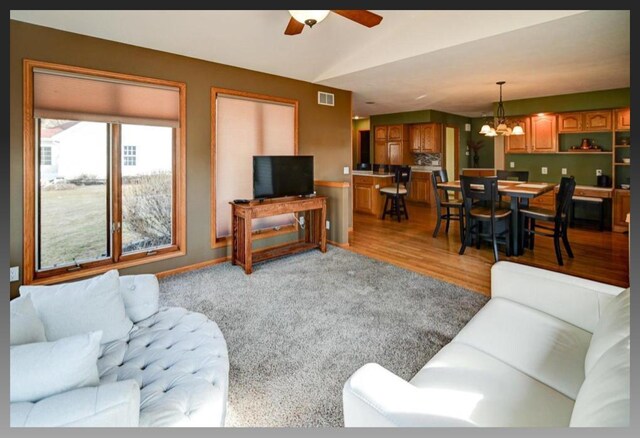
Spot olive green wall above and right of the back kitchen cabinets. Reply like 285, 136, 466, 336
370, 110, 472, 169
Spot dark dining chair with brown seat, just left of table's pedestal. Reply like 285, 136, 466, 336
459, 175, 511, 262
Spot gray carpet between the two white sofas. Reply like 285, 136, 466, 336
160, 246, 487, 427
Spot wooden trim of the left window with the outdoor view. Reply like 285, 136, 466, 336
22, 59, 187, 284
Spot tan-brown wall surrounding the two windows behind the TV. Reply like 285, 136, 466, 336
9, 20, 351, 296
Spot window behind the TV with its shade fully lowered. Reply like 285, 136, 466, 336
211, 88, 298, 247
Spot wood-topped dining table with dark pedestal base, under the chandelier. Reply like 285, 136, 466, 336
438, 180, 557, 256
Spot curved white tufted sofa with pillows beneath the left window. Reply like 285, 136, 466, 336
10, 271, 229, 427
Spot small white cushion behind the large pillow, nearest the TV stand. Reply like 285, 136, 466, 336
120, 274, 160, 322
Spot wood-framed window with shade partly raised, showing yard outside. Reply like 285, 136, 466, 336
24, 61, 186, 284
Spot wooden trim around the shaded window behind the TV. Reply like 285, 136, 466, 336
210, 87, 298, 248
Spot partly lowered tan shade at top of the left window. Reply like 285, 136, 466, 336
33, 69, 180, 128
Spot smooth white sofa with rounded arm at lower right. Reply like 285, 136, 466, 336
343, 261, 630, 427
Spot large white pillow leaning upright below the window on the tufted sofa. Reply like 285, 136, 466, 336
20, 269, 133, 343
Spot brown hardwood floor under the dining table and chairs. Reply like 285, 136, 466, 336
348, 203, 629, 296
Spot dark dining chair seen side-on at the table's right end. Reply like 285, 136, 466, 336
518, 176, 576, 266
